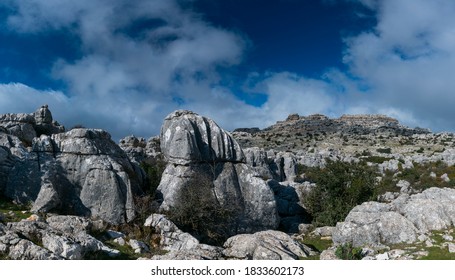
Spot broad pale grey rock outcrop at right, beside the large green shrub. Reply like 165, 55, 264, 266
333, 188, 455, 246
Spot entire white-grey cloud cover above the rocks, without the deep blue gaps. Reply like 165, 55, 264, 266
0, 0, 455, 138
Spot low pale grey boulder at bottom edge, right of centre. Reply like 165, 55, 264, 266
223, 230, 314, 260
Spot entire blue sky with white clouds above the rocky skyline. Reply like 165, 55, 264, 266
0, 0, 455, 139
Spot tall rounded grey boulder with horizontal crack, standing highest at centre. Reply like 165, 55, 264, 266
158, 110, 279, 234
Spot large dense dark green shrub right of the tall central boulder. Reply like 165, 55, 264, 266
303, 161, 377, 226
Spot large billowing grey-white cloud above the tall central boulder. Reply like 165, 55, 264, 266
3, 0, 249, 138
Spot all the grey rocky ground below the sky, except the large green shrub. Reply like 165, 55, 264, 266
0, 106, 455, 259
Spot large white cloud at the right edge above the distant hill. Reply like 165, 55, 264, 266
345, 0, 455, 130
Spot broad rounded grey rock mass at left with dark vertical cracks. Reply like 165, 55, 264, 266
0, 129, 142, 224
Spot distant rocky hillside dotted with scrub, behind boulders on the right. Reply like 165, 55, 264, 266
233, 114, 440, 154
